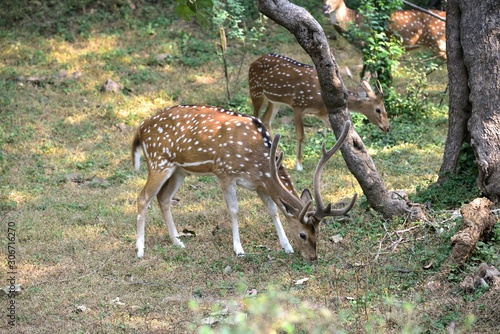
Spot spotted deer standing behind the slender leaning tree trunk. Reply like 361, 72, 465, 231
248, 54, 390, 171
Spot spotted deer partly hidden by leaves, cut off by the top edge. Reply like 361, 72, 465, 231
323, 0, 446, 60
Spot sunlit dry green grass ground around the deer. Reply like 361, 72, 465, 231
0, 1, 500, 333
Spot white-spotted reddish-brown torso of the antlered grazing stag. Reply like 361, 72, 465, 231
136, 105, 289, 186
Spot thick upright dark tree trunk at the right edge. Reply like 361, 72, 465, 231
438, 0, 500, 202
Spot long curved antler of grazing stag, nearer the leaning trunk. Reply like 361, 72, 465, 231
310, 121, 357, 221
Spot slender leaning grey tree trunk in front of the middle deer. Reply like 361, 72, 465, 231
259, 0, 425, 219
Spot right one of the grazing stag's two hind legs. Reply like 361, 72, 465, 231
157, 169, 185, 248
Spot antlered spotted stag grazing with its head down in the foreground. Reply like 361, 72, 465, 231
132, 106, 356, 261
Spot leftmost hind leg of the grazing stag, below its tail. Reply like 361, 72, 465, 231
135, 169, 174, 259
